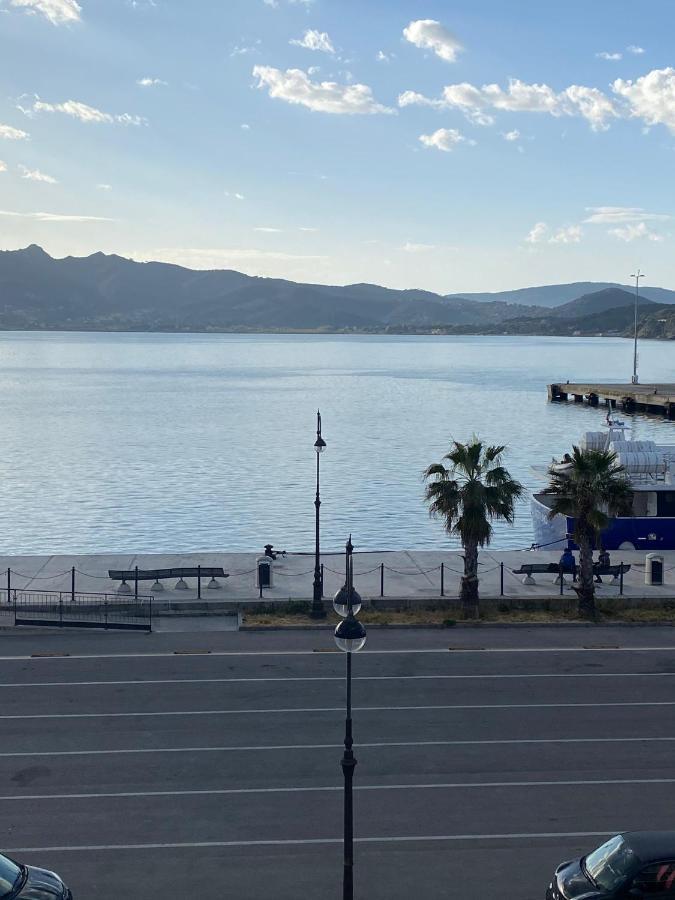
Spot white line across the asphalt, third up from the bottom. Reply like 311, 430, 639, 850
0, 737, 675, 759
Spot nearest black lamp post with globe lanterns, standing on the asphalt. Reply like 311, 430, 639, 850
333, 535, 366, 900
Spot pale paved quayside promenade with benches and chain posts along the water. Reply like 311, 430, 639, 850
0, 550, 675, 602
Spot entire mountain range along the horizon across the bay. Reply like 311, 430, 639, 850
0, 244, 675, 337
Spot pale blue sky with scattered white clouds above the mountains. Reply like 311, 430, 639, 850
0, 0, 675, 293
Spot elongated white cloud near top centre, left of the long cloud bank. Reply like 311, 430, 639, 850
253, 66, 394, 115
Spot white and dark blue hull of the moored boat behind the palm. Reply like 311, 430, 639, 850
531, 496, 675, 551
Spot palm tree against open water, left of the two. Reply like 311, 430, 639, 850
424, 436, 523, 619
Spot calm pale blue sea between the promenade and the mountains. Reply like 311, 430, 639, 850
0, 333, 675, 554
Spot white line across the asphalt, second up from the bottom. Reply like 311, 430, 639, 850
0, 778, 675, 802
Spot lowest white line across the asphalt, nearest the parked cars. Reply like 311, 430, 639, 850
5, 828, 622, 855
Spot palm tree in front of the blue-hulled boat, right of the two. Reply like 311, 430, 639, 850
545, 447, 633, 618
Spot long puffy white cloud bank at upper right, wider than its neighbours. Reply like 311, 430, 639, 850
398, 78, 618, 131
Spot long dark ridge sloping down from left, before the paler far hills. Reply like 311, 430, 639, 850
0, 244, 530, 331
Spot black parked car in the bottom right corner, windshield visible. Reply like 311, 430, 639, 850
546, 831, 675, 900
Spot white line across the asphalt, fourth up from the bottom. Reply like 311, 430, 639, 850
0, 700, 675, 721
